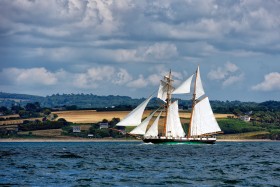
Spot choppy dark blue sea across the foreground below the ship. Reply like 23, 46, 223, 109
0, 142, 280, 186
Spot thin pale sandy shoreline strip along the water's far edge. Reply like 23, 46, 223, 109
0, 138, 279, 143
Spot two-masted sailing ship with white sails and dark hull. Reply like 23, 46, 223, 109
117, 67, 221, 144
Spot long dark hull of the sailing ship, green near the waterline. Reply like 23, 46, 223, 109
143, 139, 216, 144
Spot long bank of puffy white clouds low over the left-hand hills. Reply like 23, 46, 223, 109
0, 66, 135, 89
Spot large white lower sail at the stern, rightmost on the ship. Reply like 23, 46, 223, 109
191, 97, 221, 136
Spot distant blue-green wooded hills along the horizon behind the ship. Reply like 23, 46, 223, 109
0, 92, 280, 114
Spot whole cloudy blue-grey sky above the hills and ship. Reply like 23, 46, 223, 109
0, 0, 280, 102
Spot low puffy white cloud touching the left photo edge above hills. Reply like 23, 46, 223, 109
1, 68, 57, 86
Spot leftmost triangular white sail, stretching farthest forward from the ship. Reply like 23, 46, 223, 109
116, 96, 152, 126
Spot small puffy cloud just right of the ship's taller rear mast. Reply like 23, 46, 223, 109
207, 62, 244, 86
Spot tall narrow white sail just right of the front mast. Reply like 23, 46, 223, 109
166, 101, 185, 137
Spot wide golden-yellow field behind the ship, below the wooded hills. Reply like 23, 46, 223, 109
53, 110, 233, 123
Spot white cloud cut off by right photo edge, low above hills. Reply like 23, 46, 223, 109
252, 72, 280, 91
